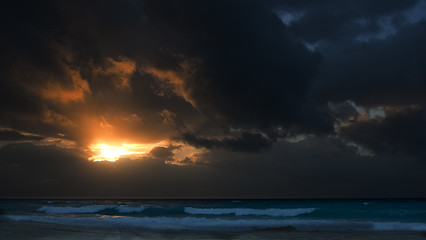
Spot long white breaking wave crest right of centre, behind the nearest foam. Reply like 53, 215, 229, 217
185, 207, 315, 217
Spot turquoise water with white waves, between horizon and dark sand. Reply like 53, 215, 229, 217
0, 200, 426, 232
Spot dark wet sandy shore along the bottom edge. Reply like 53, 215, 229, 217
0, 220, 426, 240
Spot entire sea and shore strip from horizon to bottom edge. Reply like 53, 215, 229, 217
0, 200, 426, 240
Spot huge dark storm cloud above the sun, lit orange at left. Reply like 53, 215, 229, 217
2, 1, 332, 149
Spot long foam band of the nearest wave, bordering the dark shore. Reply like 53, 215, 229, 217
6, 215, 426, 231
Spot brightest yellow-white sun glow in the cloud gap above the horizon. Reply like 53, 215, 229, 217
89, 142, 164, 162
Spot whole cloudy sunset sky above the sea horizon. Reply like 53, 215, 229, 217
0, 0, 426, 198
